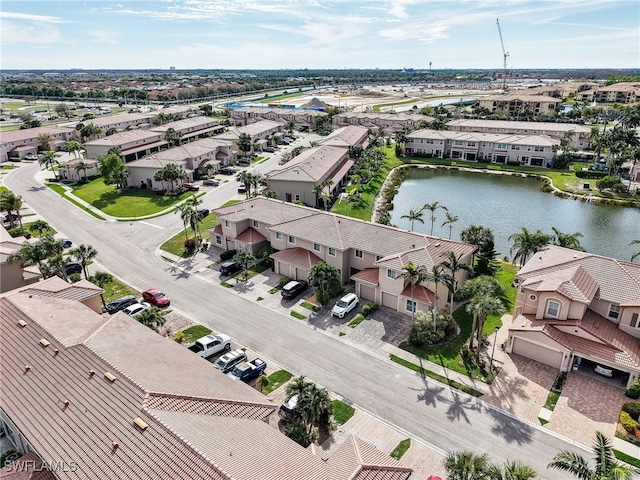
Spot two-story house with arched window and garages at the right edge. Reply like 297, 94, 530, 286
506, 245, 640, 384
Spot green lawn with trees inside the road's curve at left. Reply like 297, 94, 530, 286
72, 178, 199, 217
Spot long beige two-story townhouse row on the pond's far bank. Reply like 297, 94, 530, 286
405, 129, 560, 167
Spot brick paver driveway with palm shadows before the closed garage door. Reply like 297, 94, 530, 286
482, 351, 558, 424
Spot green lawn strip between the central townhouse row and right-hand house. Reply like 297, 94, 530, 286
400, 262, 517, 379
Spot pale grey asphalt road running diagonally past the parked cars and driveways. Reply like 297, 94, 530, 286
5, 159, 591, 480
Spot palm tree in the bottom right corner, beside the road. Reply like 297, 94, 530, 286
548, 432, 640, 480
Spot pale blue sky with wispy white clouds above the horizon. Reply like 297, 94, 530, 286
0, 0, 640, 69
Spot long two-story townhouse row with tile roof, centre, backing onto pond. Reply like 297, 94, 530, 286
210, 197, 476, 314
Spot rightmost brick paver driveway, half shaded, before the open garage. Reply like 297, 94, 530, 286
546, 372, 628, 445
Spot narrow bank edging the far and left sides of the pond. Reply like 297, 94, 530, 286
371, 164, 640, 222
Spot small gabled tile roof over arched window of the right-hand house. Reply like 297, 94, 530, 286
522, 265, 599, 305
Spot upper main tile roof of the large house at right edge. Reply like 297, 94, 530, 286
516, 245, 640, 303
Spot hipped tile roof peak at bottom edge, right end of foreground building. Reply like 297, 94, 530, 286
327, 435, 412, 480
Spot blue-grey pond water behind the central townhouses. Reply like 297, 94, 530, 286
390, 169, 640, 261
